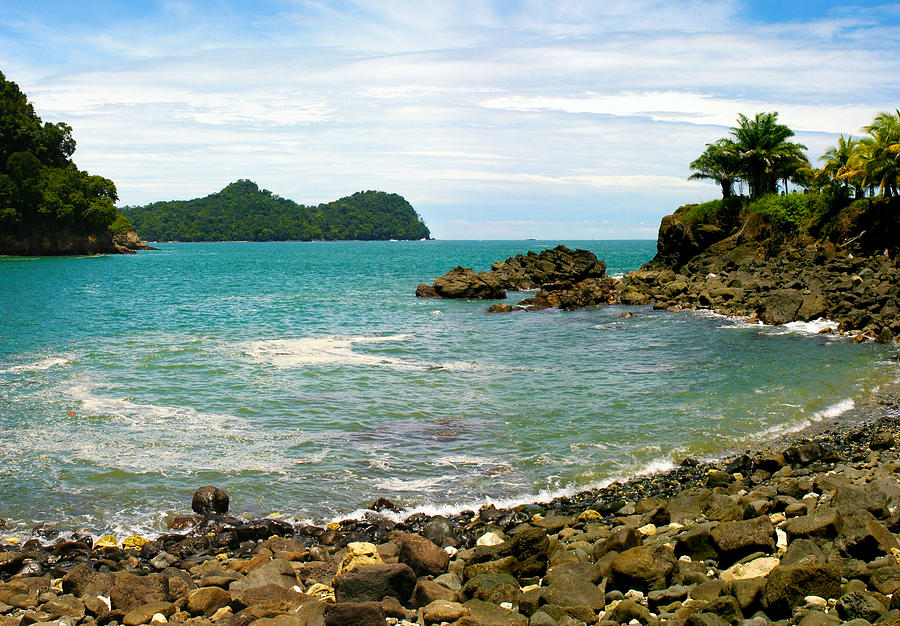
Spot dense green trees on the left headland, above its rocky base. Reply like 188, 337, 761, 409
0, 73, 124, 238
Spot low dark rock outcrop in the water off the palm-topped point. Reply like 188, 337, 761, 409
416, 245, 607, 300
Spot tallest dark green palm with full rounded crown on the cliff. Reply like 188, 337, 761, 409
731, 112, 809, 198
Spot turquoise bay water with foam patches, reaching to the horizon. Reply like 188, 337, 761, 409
0, 241, 897, 533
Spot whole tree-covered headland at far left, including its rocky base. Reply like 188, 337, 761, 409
0, 72, 143, 255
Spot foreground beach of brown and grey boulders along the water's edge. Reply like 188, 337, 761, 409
0, 384, 900, 626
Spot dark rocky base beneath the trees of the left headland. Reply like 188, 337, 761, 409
0, 231, 155, 256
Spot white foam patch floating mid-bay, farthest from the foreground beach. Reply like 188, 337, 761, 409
244, 335, 412, 369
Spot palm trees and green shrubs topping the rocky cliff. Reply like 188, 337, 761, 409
673, 110, 900, 249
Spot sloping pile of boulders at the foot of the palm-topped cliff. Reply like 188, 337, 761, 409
616, 242, 900, 343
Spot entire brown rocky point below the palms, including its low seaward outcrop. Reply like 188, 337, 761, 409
416, 207, 900, 343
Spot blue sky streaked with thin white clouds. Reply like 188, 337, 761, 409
0, 0, 900, 239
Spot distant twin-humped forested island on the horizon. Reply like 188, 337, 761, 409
121, 180, 430, 241
